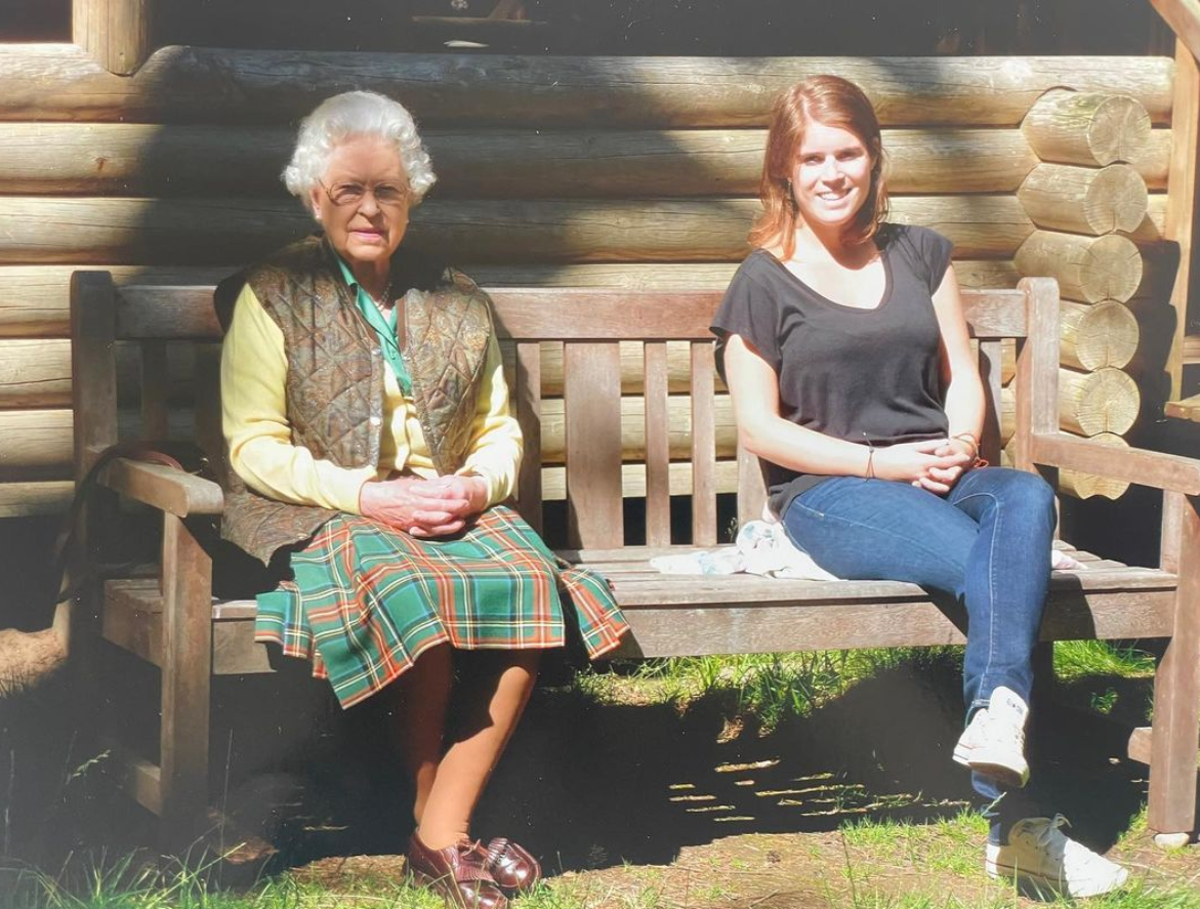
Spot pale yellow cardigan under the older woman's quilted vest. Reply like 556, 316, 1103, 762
221, 285, 521, 514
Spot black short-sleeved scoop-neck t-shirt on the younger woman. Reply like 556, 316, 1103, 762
712, 224, 950, 514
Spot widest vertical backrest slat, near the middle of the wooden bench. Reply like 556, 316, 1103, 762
563, 341, 625, 547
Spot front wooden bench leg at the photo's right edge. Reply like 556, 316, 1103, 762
1150, 493, 1200, 833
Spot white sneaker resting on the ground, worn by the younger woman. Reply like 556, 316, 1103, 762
984, 814, 1129, 897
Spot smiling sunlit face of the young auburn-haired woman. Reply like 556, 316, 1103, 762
792, 120, 872, 228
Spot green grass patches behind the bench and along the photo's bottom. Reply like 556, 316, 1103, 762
0, 642, 1200, 909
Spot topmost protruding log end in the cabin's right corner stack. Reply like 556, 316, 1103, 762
1021, 89, 1151, 167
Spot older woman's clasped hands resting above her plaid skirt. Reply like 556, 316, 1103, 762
359, 475, 487, 537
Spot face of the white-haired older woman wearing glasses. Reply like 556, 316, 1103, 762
312, 136, 410, 267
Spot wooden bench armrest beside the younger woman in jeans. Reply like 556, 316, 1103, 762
1032, 433, 1200, 495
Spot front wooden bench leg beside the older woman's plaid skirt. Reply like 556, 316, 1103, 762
160, 514, 212, 850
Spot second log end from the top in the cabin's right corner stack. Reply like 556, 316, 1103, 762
1016, 164, 1150, 236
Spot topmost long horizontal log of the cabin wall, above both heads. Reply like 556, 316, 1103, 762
0, 44, 1175, 128
